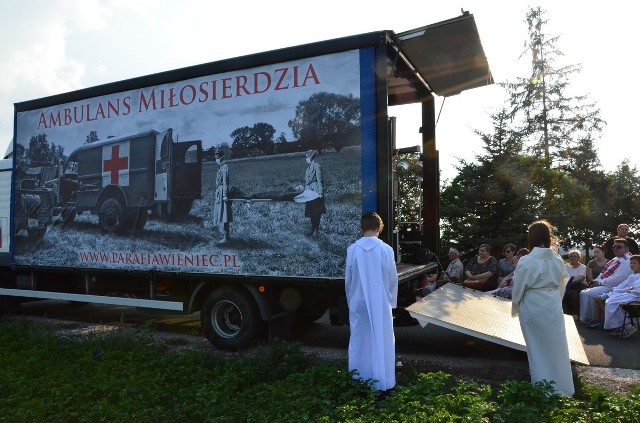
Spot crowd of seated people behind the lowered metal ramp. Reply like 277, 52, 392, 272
416, 224, 640, 338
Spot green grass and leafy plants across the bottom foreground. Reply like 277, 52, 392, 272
0, 320, 640, 423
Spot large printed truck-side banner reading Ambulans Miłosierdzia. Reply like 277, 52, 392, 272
13, 51, 362, 277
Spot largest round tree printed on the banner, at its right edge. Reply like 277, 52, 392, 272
289, 92, 360, 153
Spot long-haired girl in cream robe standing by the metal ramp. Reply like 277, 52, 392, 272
511, 220, 575, 396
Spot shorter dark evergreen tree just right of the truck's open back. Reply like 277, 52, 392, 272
441, 110, 539, 257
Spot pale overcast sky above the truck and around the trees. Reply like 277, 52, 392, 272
0, 0, 640, 178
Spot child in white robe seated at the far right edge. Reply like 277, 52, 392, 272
604, 255, 640, 332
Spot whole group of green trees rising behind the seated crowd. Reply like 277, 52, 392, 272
441, 7, 640, 259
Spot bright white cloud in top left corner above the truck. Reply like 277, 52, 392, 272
0, 0, 110, 151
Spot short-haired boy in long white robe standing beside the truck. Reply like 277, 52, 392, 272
345, 212, 398, 391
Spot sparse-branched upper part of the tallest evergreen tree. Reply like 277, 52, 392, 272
503, 7, 605, 169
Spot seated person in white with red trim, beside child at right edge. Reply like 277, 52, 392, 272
579, 238, 631, 327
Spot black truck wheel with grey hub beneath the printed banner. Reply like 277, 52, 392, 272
200, 287, 262, 351
